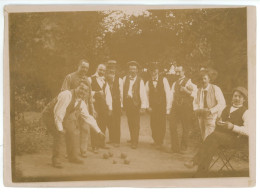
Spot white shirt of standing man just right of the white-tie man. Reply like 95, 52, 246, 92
145, 77, 171, 113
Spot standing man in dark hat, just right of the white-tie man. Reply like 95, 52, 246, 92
146, 63, 171, 148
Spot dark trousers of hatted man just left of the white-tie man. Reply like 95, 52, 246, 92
107, 110, 121, 144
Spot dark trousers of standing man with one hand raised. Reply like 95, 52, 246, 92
170, 102, 193, 152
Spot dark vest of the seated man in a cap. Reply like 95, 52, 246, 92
221, 106, 247, 126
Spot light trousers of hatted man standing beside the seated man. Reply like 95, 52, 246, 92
198, 113, 218, 141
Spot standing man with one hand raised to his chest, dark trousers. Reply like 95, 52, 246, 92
167, 65, 197, 153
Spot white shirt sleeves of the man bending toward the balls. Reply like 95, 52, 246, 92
54, 90, 101, 133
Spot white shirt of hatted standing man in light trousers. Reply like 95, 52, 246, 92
193, 84, 226, 116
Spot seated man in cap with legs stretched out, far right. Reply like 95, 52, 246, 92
185, 87, 249, 177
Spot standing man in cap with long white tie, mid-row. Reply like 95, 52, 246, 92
123, 61, 147, 149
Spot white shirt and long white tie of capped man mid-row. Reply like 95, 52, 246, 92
123, 76, 148, 109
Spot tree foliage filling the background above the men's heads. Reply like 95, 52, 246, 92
9, 8, 247, 109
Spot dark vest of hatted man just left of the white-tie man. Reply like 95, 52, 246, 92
109, 76, 121, 112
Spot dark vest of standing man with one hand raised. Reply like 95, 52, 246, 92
173, 77, 193, 106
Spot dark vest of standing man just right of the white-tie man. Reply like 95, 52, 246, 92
148, 76, 166, 110
